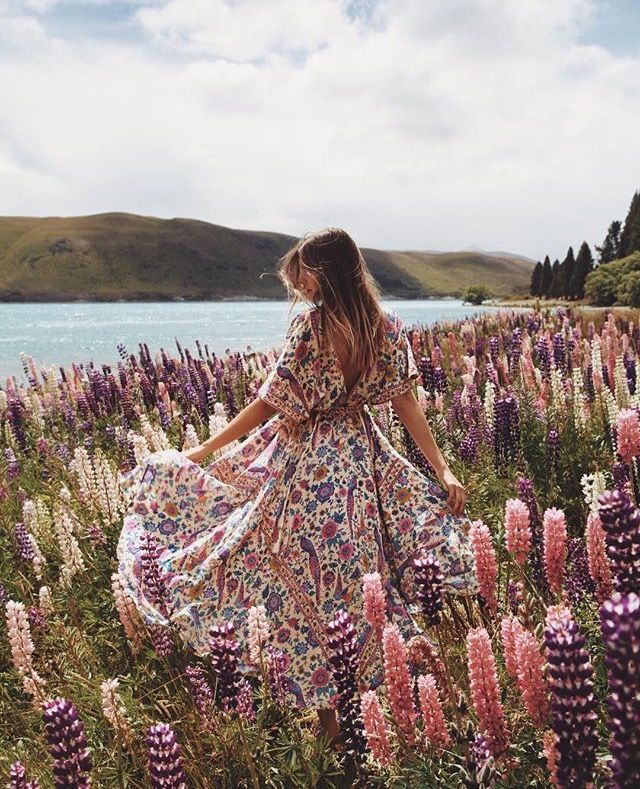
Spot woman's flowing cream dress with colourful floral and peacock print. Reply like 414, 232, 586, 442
117, 308, 478, 708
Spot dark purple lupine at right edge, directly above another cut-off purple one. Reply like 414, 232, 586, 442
598, 490, 640, 594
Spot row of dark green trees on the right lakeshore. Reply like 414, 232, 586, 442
530, 191, 640, 303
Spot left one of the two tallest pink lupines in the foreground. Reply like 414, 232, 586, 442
382, 623, 417, 745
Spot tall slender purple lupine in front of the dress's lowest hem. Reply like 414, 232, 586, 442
327, 609, 367, 769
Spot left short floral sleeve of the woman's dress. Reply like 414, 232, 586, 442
258, 312, 316, 422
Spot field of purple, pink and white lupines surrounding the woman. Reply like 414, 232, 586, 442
0, 308, 640, 789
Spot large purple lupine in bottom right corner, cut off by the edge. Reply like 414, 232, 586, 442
600, 592, 640, 789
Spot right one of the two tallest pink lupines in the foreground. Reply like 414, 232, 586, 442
467, 627, 509, 758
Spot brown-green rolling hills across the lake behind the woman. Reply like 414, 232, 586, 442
0, 212, 533, 301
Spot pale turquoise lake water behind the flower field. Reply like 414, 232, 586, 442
0, 299, 520, 385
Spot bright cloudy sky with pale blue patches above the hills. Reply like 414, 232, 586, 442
0, 0, 640, 260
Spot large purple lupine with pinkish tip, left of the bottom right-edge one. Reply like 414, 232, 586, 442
544, 605, 598, 787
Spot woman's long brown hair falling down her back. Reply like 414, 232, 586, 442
278, 227, 386, 370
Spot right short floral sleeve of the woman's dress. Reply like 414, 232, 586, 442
367, 315, 419, 405
